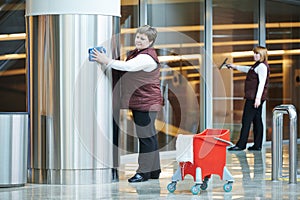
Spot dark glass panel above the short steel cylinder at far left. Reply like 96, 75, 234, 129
0, 0, 27, 112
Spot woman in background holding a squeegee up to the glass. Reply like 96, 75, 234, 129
227, 46, 270, 151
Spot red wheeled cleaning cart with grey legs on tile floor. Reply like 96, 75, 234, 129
167, 129, 234, 194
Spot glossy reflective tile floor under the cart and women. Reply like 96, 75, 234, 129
0, 144, 300, 200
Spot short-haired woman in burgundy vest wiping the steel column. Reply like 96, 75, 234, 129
93, 25, 162, 182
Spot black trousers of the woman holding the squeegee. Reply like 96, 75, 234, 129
236, 100, 264, 149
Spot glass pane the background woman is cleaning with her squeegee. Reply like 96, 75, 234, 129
213, 0, 259, 142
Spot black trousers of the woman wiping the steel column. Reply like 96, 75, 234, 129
132, 110, 160, 178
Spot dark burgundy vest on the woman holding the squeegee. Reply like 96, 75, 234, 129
244, 62, 270, 101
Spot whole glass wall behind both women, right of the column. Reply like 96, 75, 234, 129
121, 0, 300, 150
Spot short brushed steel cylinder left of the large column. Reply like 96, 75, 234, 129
0, 112, 29, 187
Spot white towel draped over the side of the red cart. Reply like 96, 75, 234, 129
176, 134, 194, 163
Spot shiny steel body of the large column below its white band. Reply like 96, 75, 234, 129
26, 14, 115, 184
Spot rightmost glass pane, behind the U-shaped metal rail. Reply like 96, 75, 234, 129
266, 0, 300, 139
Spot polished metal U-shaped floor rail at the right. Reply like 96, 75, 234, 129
272, 104, 297, 183
